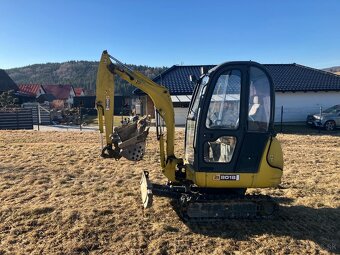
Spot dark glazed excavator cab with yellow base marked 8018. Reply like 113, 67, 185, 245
185, 61, 282, 188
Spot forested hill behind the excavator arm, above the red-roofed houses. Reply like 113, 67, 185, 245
6, 61, 167, 95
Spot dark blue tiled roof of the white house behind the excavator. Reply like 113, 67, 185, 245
134, 64, 340, 95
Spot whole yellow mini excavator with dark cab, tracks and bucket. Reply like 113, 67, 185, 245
96, 51, 283, 221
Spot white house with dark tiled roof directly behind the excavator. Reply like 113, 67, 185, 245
134, 64, 340, 125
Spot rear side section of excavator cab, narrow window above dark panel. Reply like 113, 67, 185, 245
235, 66, 275, 173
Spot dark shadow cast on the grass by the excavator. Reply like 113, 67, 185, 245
174, 198, 340, 254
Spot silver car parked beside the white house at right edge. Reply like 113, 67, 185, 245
307, 104, 340, 130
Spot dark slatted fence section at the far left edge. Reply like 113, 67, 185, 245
0, 108, 33, 130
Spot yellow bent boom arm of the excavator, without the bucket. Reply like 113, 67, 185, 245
96, 51, 177, 180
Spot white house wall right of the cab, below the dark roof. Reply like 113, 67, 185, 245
275, 92, 340, 122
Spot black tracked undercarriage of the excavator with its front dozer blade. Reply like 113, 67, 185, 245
140, 171, 279, 222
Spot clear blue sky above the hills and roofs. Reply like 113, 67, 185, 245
0, 0, 340, 69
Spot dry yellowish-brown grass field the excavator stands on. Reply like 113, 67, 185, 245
0, 131, 340, 254
